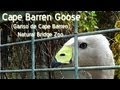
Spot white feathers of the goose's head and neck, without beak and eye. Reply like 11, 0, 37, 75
62, 34, 115, 79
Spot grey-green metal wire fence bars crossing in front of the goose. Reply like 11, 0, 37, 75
0, 10, 120, 79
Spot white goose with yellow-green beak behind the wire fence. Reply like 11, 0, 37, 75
51, 34, 115, 79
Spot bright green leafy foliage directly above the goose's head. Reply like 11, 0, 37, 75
78, 11, 98, 32
